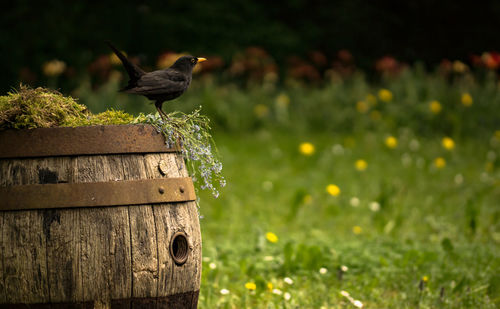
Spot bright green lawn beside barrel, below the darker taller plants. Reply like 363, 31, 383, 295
195, 130, 500, 308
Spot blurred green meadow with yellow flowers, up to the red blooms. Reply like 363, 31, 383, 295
74, 66, 500, 308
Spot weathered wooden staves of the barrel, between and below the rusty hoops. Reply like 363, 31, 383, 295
0, 153, 201, 308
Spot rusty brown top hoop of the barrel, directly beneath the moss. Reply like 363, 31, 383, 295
0, 124, 180, 159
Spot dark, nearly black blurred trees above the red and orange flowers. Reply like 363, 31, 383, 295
0, 0, 500, 92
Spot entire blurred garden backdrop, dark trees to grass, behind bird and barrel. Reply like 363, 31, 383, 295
0, 0, 500, 308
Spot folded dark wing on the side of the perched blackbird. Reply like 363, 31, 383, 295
126, 70, 189, 95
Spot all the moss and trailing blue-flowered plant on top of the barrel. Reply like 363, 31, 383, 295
0, 85, 226, 197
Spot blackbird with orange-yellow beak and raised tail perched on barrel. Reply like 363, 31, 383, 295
106, 42, 206, 119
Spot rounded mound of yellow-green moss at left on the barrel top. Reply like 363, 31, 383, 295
0, 85, 89, 129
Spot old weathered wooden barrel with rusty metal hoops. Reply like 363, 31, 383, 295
0, 125, 201, 308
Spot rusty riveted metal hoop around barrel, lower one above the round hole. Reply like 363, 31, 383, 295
0, 177, 196, 211
